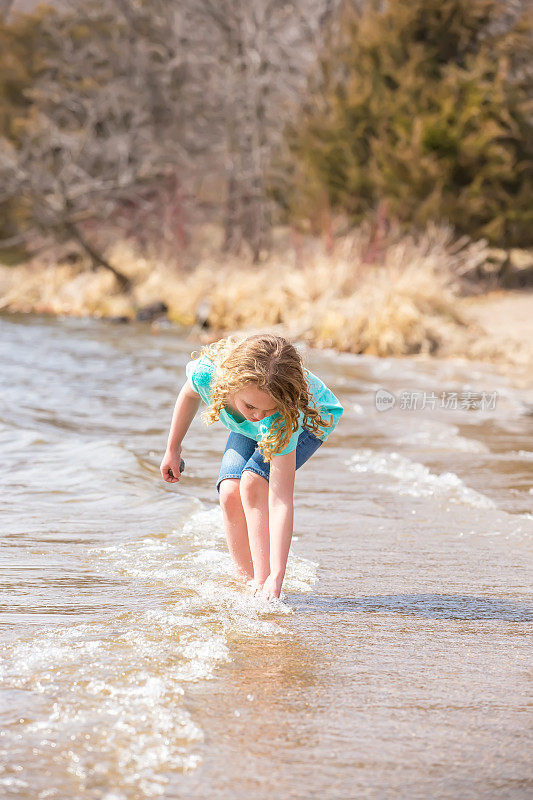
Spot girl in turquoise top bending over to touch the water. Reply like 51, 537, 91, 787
160, 334, 343, 600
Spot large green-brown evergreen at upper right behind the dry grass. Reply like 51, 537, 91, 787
284, 0, 533, 246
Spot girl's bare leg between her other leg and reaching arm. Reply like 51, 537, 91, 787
240, 469, 270, 586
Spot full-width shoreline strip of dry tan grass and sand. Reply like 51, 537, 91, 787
0, 228, 533, 374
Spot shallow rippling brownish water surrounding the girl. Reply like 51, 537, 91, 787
0, 317, 533, 800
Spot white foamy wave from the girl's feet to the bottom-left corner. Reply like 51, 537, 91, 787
0, 508, 317, 800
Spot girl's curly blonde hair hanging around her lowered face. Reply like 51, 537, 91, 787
193, 333, 333, 461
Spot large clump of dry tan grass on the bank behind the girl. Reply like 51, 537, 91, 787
162, 222, 478, 356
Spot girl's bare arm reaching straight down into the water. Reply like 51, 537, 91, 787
263, 450, 296, 600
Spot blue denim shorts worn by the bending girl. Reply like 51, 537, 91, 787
217, 428, 324, 492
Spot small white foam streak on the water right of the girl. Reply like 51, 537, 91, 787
346, 448, 496, 508
